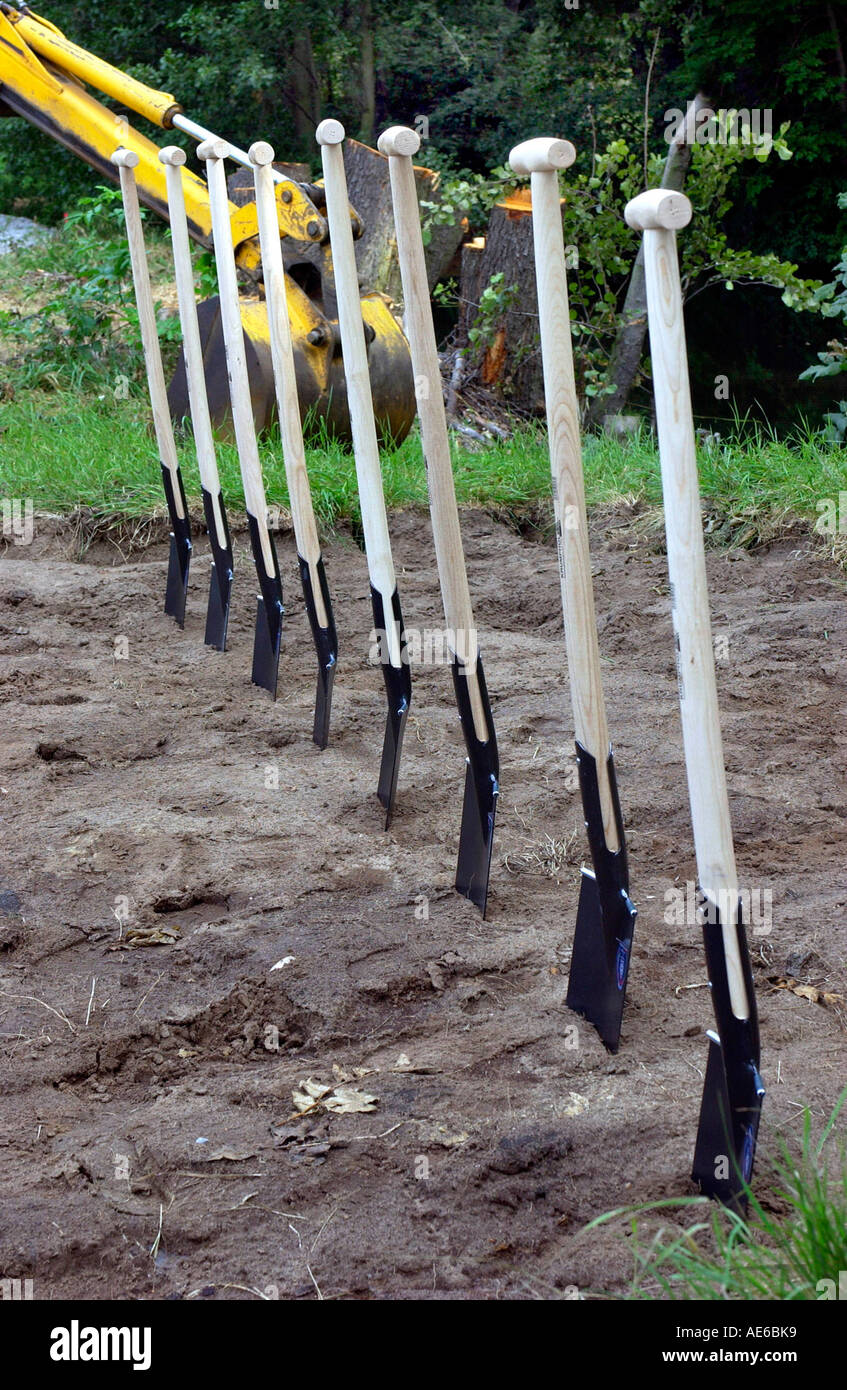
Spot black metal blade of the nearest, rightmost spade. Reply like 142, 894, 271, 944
691, 902, 765, 1215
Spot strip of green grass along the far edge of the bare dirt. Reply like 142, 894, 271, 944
0, 391, 847, 539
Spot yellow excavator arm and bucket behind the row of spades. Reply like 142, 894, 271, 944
0, 0, 414, 441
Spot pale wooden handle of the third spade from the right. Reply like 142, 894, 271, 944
378, 125, 490, 744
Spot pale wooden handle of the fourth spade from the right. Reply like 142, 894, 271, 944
316, 121, 402, 666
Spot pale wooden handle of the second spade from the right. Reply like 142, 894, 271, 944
509, 139, 620, 853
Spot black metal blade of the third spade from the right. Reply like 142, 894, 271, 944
453, 656, 499, 916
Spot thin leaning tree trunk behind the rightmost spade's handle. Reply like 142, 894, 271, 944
588, 92, 708, 425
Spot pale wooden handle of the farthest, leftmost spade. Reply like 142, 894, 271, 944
111, 149, 185, 520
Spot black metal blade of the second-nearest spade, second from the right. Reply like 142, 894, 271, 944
566, 742, 637, 1052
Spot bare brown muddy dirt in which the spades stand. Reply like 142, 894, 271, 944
0, 510, 847, 1300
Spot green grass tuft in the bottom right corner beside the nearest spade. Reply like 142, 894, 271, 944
586, 1088, 847, 1301
